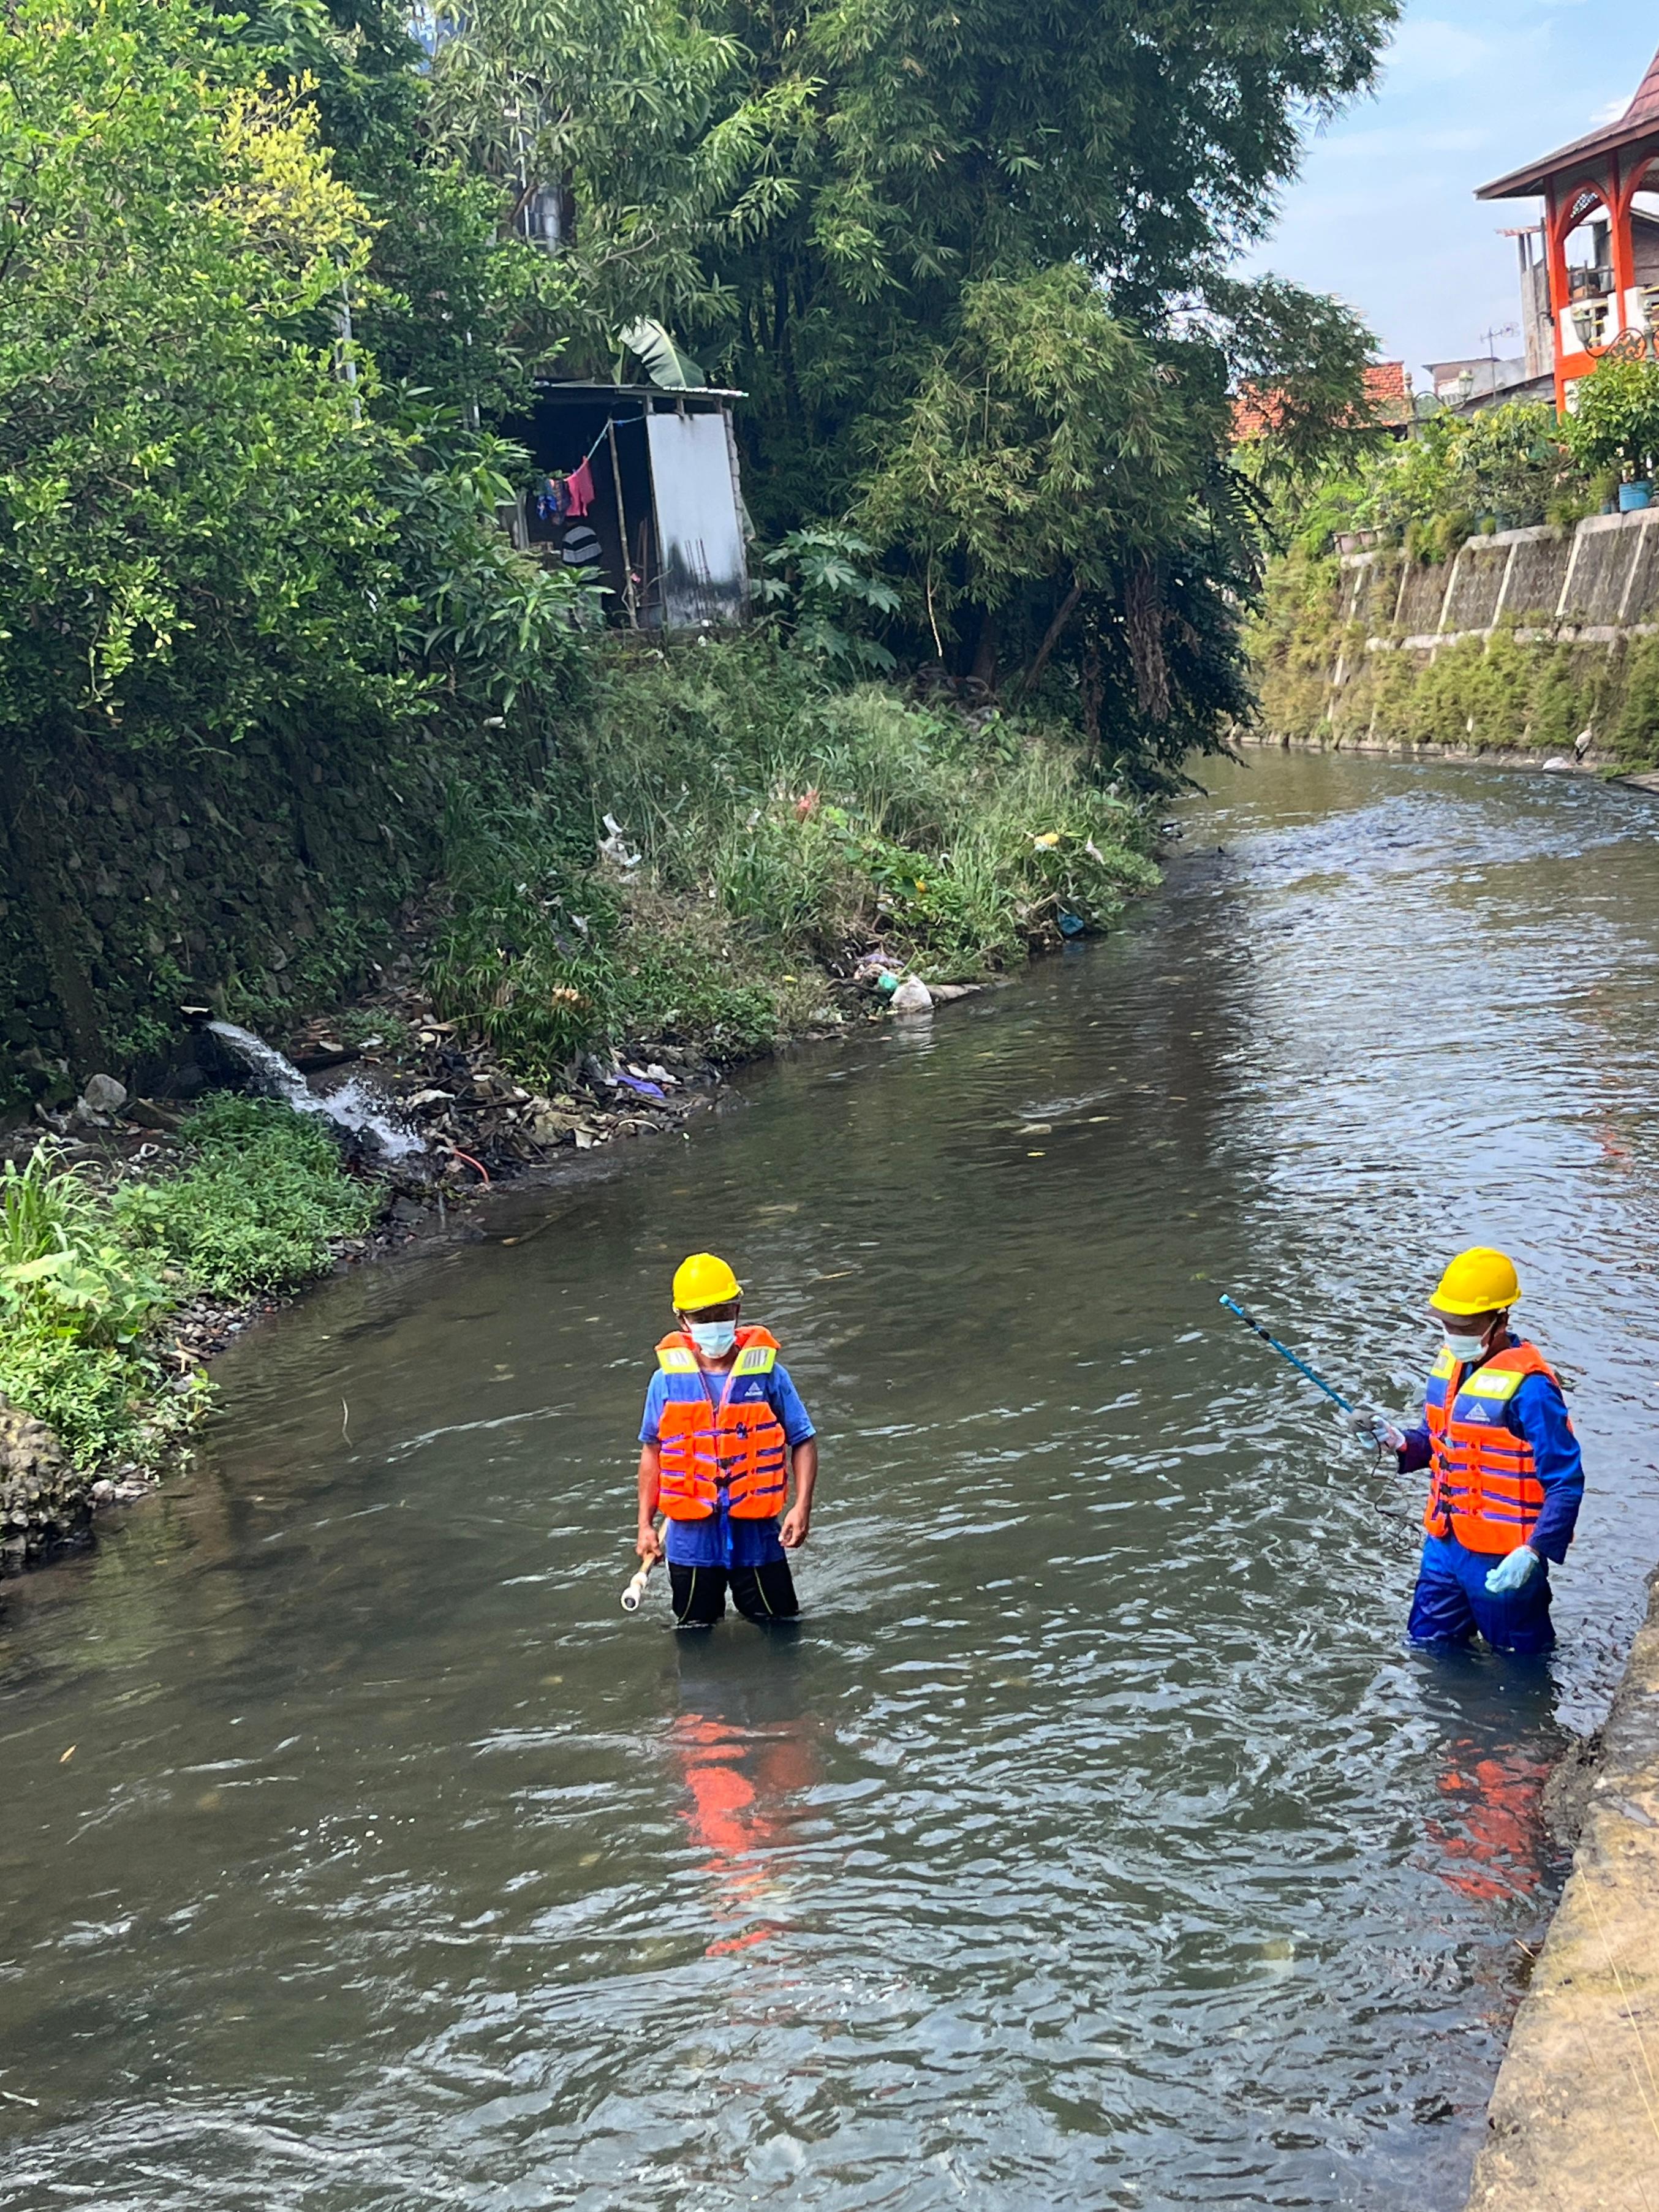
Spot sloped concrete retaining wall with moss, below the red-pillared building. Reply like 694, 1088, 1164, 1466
1252, 509, 1659, 770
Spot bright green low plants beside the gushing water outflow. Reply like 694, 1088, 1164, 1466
0, 1097, 380, 1469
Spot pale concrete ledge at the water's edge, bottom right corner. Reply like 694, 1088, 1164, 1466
1468, 1572, 1659, 2212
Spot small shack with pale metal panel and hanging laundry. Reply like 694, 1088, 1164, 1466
511, 378, 750, 630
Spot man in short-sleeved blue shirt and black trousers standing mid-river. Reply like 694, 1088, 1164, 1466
637, 1252, 818, 1628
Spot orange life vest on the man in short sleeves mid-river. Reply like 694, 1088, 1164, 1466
657, 1329, 790, 1520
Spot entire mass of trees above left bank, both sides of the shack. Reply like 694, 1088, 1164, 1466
0, 0, 1394, 787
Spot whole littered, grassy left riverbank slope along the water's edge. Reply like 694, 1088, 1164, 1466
0, 637, 1157, 1566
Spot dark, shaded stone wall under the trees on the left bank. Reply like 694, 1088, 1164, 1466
0, 730, 575, 1108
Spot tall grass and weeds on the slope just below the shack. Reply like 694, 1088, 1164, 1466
431, 635, 1157, 1084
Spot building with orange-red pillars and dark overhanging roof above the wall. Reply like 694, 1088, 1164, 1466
1475, 43, 1659, 413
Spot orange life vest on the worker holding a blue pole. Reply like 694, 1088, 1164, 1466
1423, 1345, 1571, 1550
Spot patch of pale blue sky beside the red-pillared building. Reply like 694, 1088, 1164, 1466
1245, 0, 1659, 376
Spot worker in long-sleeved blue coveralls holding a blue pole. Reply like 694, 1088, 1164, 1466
1378, 1245, 1584, 1652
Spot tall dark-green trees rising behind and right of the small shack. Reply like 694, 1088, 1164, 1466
415, 0, 1394, 752
